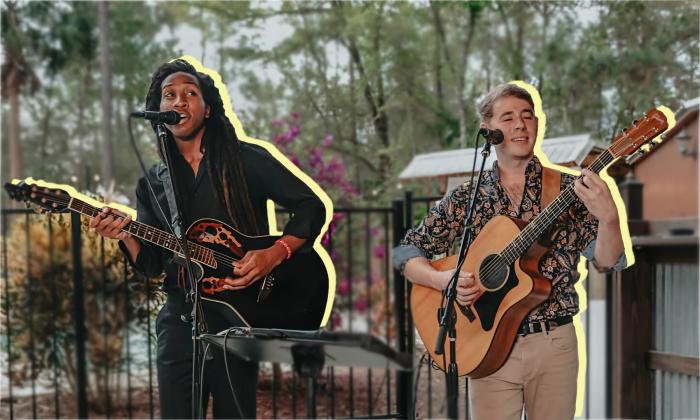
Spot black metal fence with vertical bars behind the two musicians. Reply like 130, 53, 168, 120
0, 192, 604, 418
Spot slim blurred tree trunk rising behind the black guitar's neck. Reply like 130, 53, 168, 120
98, 1, 114, 188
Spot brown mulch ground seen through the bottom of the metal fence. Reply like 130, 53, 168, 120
0, 352, 466, 418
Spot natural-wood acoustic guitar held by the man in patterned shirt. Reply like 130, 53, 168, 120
411, 109, 668, 378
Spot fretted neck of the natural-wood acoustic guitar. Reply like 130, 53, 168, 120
501, 149, 615, 263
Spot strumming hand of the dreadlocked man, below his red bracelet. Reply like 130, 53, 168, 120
224, 244, 287, 290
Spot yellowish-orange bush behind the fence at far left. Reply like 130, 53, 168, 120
0, 215, 162, 411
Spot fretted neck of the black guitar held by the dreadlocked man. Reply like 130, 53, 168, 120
68, 197, 214, 266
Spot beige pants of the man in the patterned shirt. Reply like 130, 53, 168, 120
469, 324, 578, 420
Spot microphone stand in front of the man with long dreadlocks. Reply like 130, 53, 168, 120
156, 124, 206, 419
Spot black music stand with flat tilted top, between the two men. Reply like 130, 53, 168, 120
198, 327, 413, 418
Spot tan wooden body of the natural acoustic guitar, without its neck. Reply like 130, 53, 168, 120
411, 216, 552, 378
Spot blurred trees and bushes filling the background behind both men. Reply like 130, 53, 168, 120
0, 0, 700, 411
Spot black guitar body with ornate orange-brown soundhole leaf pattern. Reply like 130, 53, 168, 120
187, 219, 328, 330
